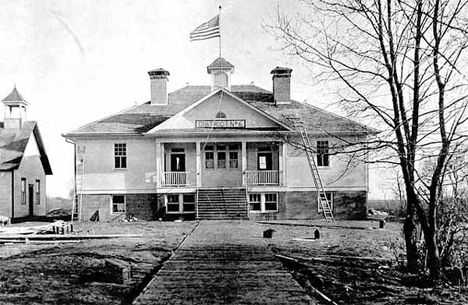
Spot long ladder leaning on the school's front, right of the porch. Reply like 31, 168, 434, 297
287, 116, 335, 221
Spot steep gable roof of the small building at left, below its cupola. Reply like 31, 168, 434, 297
0, 121, 52, 175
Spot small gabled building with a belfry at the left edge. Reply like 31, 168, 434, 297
0, 86, 52, 219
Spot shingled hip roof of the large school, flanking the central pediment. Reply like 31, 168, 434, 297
64, 85, 376, 137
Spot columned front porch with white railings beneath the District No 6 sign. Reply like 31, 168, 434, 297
156, 141, 285, 188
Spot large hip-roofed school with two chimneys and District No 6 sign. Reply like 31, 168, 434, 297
64, 57, 373, 220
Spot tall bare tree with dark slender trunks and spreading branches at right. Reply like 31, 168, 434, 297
270, 0, 468, 280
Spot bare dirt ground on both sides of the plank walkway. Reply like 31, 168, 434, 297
0, 221, 468, 305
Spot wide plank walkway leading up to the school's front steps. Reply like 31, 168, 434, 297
134, 221, 314, 305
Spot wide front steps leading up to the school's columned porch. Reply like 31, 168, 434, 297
198, 189, 248, 220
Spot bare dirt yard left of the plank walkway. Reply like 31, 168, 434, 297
0, 222, 196, 305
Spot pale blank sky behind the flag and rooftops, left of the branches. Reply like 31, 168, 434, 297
0, 0, 388, 200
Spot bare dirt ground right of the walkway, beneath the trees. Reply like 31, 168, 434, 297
263, 221, 468, 305
